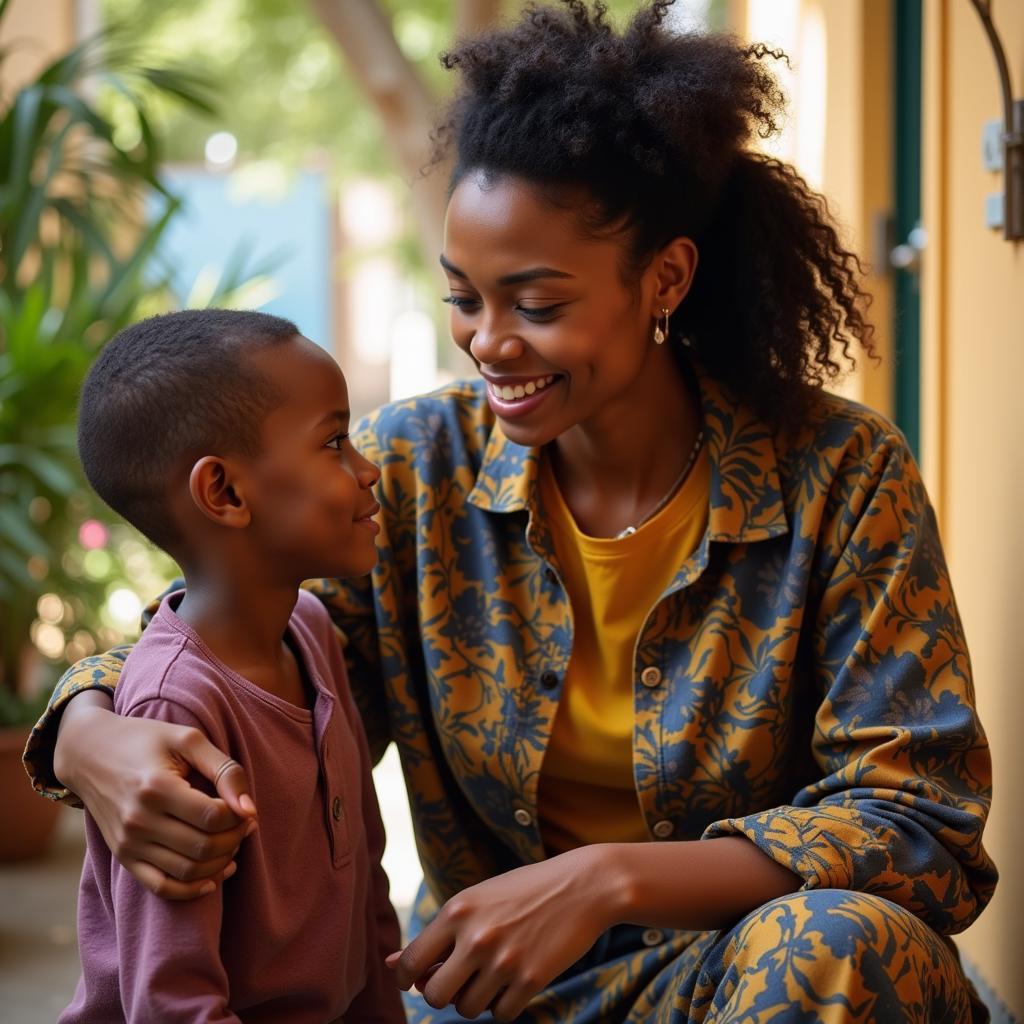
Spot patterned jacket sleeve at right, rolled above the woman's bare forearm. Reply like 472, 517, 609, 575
705, 428, 996, 934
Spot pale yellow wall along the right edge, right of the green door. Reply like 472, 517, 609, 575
922, 0, 1024, 1018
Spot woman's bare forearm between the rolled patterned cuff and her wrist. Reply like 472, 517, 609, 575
592, 836, 803, 931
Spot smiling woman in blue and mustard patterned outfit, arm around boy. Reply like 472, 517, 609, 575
30, 0, 995, 1022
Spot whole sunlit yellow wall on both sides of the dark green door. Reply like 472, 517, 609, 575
731, 0, 1024, 1019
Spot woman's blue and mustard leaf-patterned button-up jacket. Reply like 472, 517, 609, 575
27, 378, 996, 934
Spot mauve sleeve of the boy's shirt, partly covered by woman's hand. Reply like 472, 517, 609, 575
111, 699, 239, 1024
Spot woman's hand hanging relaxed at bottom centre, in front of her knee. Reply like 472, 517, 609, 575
387, 847, 614, 1021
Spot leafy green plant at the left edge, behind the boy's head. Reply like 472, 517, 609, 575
0, 0, 211, 720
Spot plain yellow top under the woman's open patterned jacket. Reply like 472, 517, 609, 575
538, 445, 711, 853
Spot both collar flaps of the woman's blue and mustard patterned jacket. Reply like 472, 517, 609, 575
467, 370, 790, 543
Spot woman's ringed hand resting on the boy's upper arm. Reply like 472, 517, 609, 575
53, 691, 256, 899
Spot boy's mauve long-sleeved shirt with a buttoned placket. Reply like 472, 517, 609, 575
60, 592, 406, 1024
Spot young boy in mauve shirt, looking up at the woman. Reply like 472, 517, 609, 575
60, 309, 406, 1024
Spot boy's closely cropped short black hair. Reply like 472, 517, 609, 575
78, 309, 299, 548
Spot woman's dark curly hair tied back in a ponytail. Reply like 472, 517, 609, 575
434, 0, 874, 422
